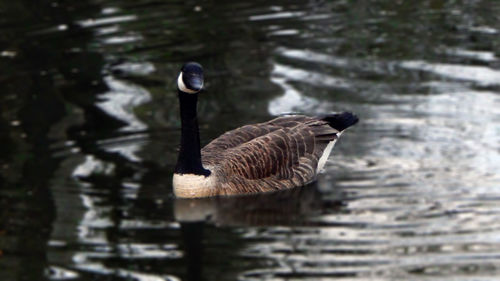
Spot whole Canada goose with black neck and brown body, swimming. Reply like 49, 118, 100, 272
173, 62, 358, 198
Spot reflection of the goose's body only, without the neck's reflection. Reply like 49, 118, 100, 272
174, 183, 342, 226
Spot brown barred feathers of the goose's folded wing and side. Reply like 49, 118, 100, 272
202, 116, 338, 195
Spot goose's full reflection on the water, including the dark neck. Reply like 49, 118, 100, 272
174, 183, 345, 280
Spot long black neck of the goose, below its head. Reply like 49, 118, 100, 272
175, 91, 210, 176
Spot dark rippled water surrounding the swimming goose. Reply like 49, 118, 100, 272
0, 0, 500, 281
